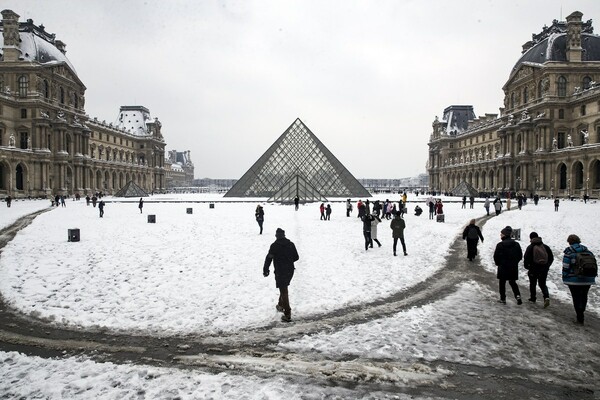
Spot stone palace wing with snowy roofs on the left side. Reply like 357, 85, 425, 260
0, 10, 166, 198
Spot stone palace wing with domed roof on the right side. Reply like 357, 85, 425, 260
427, 12, 600, 197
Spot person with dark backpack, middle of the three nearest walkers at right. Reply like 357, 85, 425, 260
523, 232, 554, 308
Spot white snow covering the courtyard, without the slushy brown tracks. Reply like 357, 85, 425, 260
0, 195, 600, 399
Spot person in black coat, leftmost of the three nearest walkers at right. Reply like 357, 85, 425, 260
494, 226, 523, 305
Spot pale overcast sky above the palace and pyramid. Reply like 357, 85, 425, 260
1, 0, 600, 178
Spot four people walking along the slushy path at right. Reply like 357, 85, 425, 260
462, 219, 598, 325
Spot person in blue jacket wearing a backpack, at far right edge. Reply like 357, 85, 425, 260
562, 234, 598, 325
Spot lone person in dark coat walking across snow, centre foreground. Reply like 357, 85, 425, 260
263, 228, 299, 322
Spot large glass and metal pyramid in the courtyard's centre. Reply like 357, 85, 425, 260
225, 118, 371, 202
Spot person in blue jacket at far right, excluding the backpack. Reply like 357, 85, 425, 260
562, 235, 596, 325
